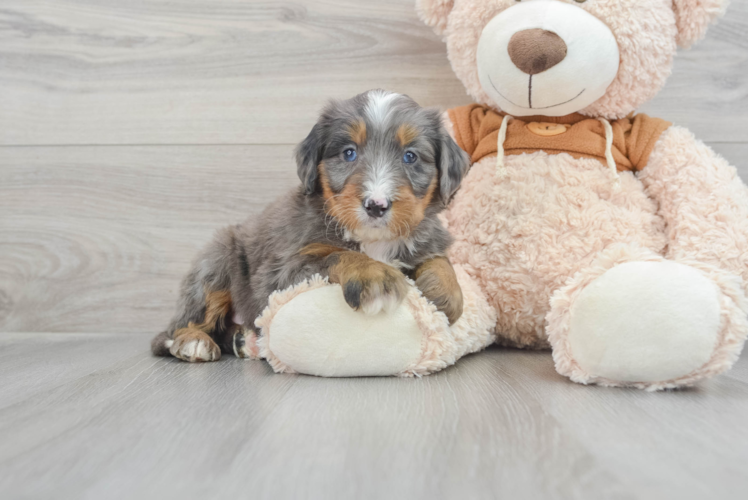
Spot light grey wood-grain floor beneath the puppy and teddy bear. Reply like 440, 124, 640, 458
0, 334, 748, 500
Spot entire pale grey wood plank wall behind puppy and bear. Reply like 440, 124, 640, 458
0, 0, 748, 332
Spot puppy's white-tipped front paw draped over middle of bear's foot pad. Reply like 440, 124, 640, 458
330, 252, 408, 314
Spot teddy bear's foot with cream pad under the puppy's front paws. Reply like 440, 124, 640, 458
256, 267, 496, 377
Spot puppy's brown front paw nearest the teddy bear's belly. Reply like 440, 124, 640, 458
415, 257, 463, 324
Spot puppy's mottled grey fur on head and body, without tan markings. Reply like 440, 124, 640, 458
152, 91, 468, 355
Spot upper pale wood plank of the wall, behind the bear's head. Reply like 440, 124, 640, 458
0, 0, 748, 145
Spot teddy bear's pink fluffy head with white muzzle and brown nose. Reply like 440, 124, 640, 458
417, 0, 728, 119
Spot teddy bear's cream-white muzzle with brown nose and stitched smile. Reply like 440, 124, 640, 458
476, 0, 620, 116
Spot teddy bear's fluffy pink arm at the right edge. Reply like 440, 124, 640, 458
639, 127, 748, 292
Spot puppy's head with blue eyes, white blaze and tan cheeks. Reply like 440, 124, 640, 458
296, 90, 469, 240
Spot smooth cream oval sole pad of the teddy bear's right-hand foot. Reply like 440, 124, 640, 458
569, 261, 721, 384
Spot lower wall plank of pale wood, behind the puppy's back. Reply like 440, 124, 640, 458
0, 144, 748, 333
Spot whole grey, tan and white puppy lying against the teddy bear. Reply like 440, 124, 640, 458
151, 90, 469, 361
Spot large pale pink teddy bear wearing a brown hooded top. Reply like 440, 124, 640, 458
247, 0, 748, 390
